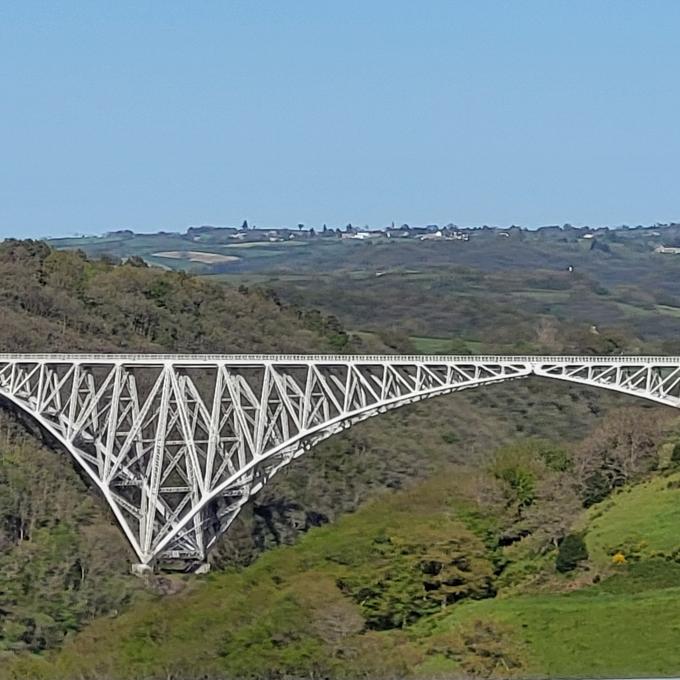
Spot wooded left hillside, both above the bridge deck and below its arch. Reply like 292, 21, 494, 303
0, 241, 352, 655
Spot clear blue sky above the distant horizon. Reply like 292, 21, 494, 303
0, 0, 680, 236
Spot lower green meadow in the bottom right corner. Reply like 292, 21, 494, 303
428, 571, 680, 678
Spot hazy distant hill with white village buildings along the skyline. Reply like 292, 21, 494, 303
49, 224, 680, 275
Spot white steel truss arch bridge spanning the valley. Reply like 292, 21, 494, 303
0, 354, 680, 564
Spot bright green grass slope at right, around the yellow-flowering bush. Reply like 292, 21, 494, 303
423, 473, 680, 677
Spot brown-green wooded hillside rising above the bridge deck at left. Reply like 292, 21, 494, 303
0, 241, 351, 353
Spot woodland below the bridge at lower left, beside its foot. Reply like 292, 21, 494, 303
0, 416, 139, 656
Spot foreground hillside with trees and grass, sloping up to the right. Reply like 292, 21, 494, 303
9, 409, 680, 680
